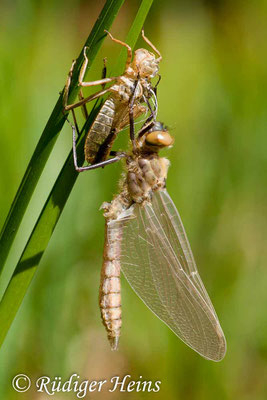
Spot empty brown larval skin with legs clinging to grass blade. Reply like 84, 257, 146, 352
63, 30, 162, 172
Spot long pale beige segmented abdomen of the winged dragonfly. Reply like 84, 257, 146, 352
99, 221, 122, 350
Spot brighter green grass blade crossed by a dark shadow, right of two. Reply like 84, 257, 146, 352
0, 0, 155, 345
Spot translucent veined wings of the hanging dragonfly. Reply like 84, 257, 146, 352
110, 190, 226, 361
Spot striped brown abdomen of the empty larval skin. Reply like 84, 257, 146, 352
84, 97, 115, 164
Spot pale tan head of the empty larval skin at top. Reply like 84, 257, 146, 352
131, 49, 159, 80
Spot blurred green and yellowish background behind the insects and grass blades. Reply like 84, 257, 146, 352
0, 0, 267, 400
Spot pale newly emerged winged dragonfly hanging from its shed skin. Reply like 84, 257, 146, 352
99, 121, 226, 361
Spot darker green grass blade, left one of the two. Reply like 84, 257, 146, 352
0, 0, 124, 273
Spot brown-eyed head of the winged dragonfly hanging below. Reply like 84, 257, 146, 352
145, 121, 174, 152
